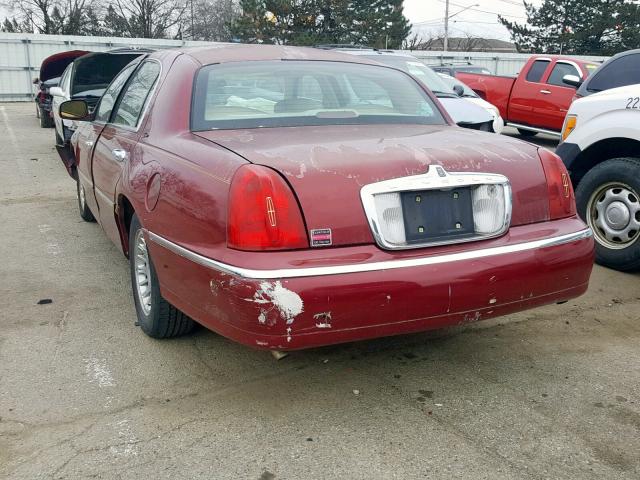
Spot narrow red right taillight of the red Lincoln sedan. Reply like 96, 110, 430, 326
538, 148, 576, 220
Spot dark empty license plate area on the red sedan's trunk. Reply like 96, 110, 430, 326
400, 187, 476, 244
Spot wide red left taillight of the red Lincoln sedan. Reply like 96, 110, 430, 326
227, 165, 309, 251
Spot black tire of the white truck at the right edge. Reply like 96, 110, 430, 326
576, 158, 640, 272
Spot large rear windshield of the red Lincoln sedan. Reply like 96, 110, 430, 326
191, 60, 445, 131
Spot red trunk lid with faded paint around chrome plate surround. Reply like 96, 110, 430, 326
196, 125, 548, 245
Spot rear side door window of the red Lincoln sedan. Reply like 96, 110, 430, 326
112, 61, 160, 128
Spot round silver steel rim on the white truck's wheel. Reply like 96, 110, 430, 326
587, 183, 640, 249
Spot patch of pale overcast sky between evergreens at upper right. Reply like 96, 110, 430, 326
404, 0, 542, 40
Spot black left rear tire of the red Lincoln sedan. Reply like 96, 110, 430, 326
129, 214, 195, 338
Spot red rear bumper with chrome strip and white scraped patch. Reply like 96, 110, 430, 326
148, 219, 594, 350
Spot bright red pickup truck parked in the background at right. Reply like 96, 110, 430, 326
456, 55, 598, 136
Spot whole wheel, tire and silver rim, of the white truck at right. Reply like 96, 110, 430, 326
576, 158, 640, 272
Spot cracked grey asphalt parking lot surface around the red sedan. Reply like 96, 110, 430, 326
0, 104, 640, 480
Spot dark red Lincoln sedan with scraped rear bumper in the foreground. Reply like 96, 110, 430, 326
60, 45, 594, 350
